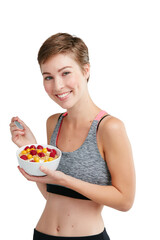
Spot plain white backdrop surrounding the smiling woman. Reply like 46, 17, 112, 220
0, 0, 160, 240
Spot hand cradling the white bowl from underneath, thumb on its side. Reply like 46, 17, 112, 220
18, 166, 67, 185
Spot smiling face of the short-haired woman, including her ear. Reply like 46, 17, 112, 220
41, 54, 89, 109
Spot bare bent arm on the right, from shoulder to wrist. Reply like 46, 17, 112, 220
65, 117, 135, 211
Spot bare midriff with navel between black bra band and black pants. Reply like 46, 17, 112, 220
36, 193, 104, 237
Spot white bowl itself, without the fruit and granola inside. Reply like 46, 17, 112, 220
16, 144, 62, 176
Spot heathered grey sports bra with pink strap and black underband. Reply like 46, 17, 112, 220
47, 111, 111, 200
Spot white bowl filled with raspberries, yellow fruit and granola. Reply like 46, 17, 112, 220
16, 144, 62, 176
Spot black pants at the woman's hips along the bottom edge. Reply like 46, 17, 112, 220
33, 229, 110, 240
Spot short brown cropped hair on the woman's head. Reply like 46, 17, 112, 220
37, 33, 89, 81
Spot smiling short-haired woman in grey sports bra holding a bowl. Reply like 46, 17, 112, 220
10, 33, 135, 240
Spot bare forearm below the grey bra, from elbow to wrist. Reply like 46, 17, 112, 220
65, 176, 131, 211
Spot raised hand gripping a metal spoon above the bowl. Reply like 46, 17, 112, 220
10, 117, 37, 147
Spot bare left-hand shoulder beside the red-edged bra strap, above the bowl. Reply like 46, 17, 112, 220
46, 113, 61, 144
